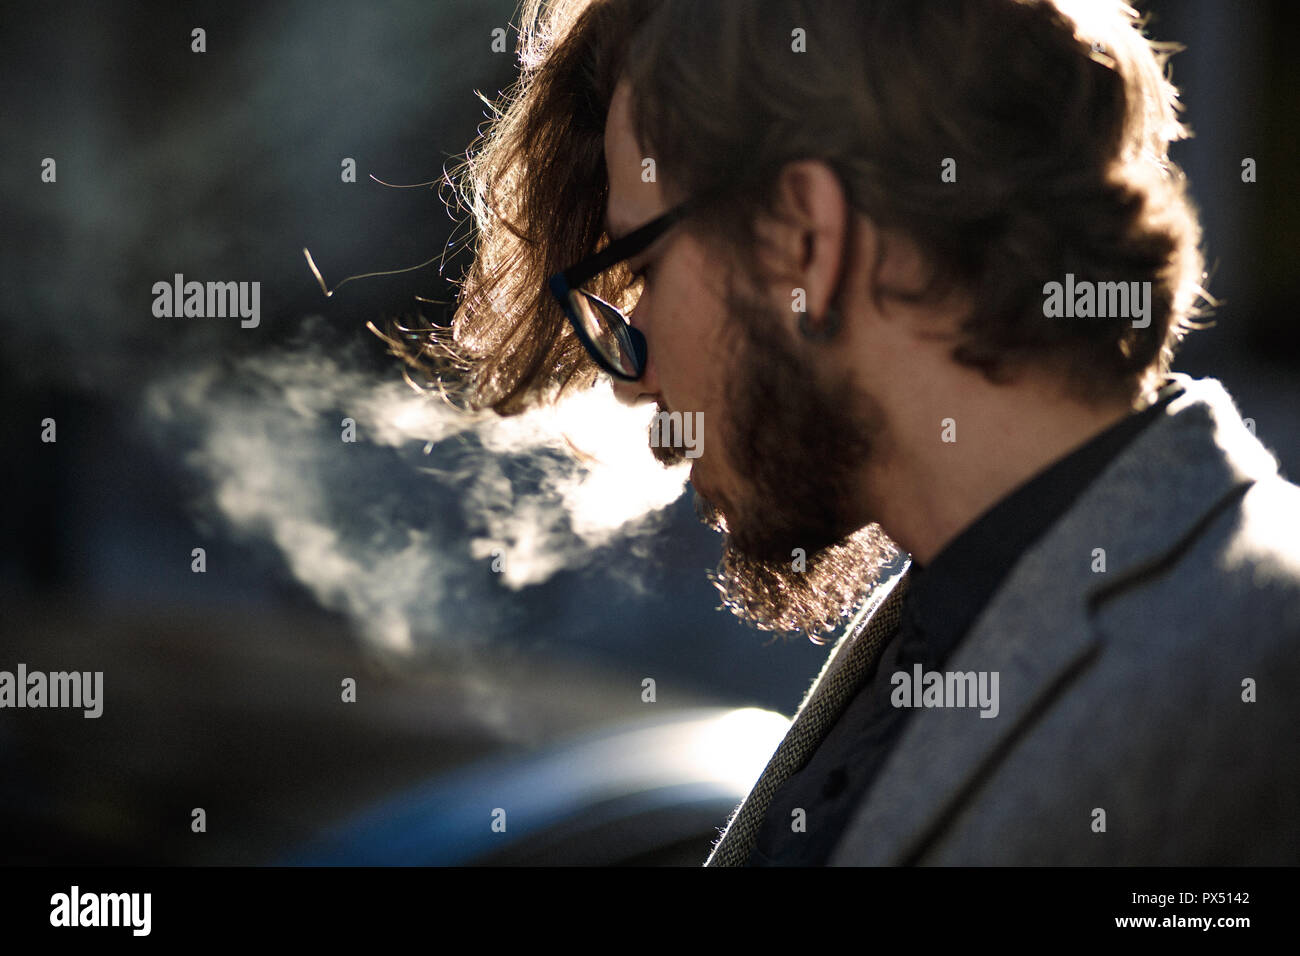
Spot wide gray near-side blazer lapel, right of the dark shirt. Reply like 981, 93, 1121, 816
829, 376, 1277, 866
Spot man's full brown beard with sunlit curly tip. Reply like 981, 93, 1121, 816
654, 269, 900, 644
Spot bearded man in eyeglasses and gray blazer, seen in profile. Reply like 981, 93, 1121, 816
397, 0, 1300, 865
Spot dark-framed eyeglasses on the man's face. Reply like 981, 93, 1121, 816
547, 199, 699, 381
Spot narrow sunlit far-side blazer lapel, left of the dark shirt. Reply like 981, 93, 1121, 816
705, 564, 907, 866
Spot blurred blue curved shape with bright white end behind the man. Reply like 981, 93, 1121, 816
276, 708, 789, 866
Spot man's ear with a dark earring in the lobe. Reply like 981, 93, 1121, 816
755, 160, 853, 329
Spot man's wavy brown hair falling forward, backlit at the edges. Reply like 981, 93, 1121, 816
387, 0, 1212, 415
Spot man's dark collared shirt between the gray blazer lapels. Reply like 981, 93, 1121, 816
748, 382, 1182, 866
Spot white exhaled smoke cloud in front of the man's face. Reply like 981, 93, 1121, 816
146, 317, 688, 652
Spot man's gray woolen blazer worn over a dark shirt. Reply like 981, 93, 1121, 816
705, 375, 1300, 866
